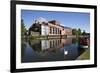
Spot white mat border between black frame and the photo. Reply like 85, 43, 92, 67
16, 5, 94, 69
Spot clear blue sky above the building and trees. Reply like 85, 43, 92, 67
21, 10, 90, 32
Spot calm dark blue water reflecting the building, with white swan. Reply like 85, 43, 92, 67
21, 38, 90, 63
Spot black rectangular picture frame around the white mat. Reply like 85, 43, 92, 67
10, 1, 97, 72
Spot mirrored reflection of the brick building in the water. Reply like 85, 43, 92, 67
29, 39, 72, 51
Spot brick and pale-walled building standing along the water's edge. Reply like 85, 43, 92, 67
29, 17, 72, 36
